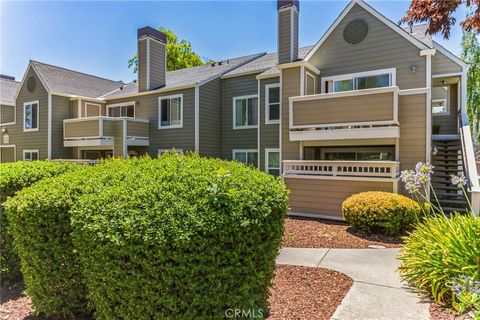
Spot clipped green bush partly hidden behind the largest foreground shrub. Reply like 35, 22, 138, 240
5, 160, 139, 318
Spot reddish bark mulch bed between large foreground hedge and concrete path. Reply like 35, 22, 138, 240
267, 265, 353, 320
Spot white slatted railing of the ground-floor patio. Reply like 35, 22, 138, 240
282, 160, 400, 179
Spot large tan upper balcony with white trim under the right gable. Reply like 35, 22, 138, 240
289, 87, 400, 141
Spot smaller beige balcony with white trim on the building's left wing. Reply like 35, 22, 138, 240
63, 116, 149, 147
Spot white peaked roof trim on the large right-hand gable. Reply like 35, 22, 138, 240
304, 0, 429, 61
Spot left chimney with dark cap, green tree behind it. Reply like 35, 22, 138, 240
137, 27, 167, 92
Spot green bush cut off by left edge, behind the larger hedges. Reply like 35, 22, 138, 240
0, 161, 77, 280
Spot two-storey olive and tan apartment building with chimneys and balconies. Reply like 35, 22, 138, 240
0, 1, 480, 219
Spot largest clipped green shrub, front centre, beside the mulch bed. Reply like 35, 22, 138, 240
71, 154, 288, 319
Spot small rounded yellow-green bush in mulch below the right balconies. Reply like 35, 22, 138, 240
342, 191, 422, 235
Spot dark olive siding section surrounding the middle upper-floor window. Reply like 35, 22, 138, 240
222, 75, 258, 159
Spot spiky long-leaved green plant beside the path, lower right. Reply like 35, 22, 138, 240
399, 215, 480, 317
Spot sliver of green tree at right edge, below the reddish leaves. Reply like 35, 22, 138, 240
461, 31, 480, 144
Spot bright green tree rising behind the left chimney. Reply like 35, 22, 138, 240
128, 27, 207, 73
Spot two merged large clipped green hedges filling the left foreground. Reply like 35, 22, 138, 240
6, 154, 288, 319
